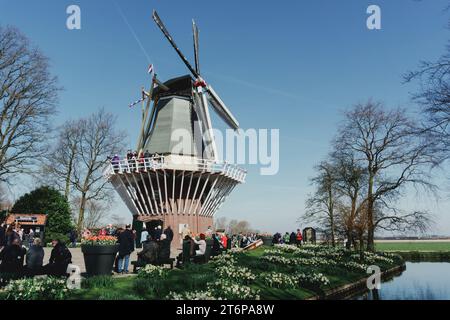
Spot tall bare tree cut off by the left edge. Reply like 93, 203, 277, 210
0, 27, 59, 182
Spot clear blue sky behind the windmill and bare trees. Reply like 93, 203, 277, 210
0, 0, 450, 234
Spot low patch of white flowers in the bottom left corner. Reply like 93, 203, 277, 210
4, 277, 68, 300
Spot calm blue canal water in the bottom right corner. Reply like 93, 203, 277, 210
353, 262, 450, 300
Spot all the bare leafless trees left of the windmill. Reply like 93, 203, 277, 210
0, 27, 126, 229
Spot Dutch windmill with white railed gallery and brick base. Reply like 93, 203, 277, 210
105, 11, 246, 246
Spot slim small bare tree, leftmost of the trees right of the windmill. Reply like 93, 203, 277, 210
301, 161, 337, 246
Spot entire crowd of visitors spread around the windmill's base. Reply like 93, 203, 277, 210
0, 218, 274, 276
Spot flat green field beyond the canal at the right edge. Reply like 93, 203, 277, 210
375, 240, 450, 251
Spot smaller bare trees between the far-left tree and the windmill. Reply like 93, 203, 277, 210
44, 109, 126, 230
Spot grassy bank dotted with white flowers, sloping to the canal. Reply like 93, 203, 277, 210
64, 246, 403, 300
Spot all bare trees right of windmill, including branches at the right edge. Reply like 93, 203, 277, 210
302, 41, 450, 250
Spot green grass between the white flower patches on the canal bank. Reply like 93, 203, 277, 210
69, 247, 403, 300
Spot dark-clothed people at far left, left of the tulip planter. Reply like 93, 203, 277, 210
0, 223, 72, 277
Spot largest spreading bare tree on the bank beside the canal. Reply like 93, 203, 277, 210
336, 101, 434, 251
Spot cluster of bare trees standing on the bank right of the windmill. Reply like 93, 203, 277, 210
303, 101, 437, 250
